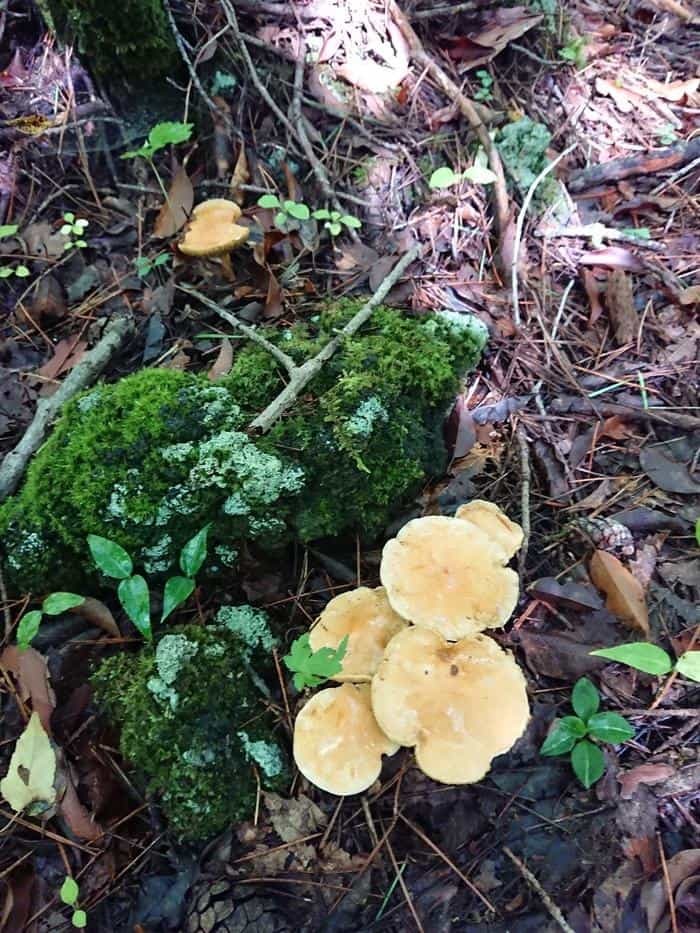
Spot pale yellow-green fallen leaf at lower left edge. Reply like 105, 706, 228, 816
0, 713, 56, 813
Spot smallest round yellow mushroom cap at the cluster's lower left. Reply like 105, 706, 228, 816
294, 684, 399, 796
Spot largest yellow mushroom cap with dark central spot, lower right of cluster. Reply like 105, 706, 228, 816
372, 627, 530, 784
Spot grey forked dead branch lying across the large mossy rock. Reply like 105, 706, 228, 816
179, 246, 420, 434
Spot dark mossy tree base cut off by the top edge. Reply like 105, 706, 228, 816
46, 0, 177, 80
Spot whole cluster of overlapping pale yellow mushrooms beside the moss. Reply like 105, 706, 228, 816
294, 499, 529, 795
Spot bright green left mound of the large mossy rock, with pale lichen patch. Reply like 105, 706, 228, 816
0, 369, 303, 591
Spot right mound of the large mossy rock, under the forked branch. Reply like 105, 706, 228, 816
225, 300, 486, 541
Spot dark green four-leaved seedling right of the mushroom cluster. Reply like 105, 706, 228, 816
540, 677, 634, 788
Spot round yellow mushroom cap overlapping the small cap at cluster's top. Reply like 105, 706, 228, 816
379, 515, 518, 640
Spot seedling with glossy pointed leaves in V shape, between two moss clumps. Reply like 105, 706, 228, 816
87, 525, 210, 641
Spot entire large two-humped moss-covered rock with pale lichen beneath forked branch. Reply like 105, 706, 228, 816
0, 301, 485, 591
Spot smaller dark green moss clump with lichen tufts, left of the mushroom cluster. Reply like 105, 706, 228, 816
92, 624, 288, 840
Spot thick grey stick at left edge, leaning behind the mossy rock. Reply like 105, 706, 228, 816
0, 317, 134, 502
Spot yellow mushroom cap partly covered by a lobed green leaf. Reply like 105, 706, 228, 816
309, 586, 408, 683
